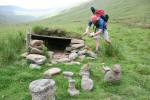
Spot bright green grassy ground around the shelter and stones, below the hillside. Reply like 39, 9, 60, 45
0, 22, 150, 100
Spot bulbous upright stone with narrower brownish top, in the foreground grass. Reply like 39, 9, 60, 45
80, 64, 94, 91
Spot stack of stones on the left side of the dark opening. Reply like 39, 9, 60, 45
22, 40, 47, 69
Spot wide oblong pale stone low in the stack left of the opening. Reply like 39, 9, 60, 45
26, 54, 46, 64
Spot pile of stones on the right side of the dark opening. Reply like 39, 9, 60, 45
57, 39, 97, 64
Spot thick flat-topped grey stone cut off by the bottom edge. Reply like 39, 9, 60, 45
29, 79, 55, 100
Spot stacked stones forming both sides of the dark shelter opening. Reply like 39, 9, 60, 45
23, 39, 97, 69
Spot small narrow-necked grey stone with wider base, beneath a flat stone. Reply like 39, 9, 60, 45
68, 80, 80, 96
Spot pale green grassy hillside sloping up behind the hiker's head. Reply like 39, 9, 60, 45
42, 0, 150, 25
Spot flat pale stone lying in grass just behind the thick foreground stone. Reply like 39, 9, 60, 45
44, 68, 61, 77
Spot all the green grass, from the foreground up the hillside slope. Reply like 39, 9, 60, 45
0, 0, 150, 100
